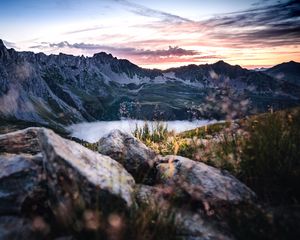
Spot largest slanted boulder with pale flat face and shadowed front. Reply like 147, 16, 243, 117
38, 129, 135, 224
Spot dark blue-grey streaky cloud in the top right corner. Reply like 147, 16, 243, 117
202, 0, 300, 46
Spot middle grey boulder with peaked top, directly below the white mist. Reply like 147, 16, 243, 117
98, 130, 156, 182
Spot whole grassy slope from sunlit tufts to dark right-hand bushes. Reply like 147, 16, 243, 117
134, 108, 300, 203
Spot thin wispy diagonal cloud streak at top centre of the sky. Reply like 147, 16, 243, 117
114, 0, 191, 22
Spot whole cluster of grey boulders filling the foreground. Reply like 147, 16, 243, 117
0, 128, 255, 240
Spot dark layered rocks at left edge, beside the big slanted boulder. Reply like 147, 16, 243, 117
0, 128, 48, 240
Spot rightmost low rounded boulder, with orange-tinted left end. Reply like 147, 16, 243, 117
157, 155, 255, 208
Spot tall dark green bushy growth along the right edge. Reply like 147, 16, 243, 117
239, 109, 300, 203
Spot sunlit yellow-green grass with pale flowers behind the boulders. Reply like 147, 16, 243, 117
133, 122, 239, 171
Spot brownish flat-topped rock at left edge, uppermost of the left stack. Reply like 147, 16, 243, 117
0, 127, 41, 154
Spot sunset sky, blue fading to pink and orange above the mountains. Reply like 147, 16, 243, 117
0, 0, 300, 69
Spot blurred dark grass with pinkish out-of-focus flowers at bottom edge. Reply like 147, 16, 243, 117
51, 201, 178, 240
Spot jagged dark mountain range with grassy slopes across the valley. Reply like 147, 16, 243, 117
0, 40, 300, 129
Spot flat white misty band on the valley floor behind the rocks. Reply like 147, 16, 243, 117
67, 120, 216, 143
